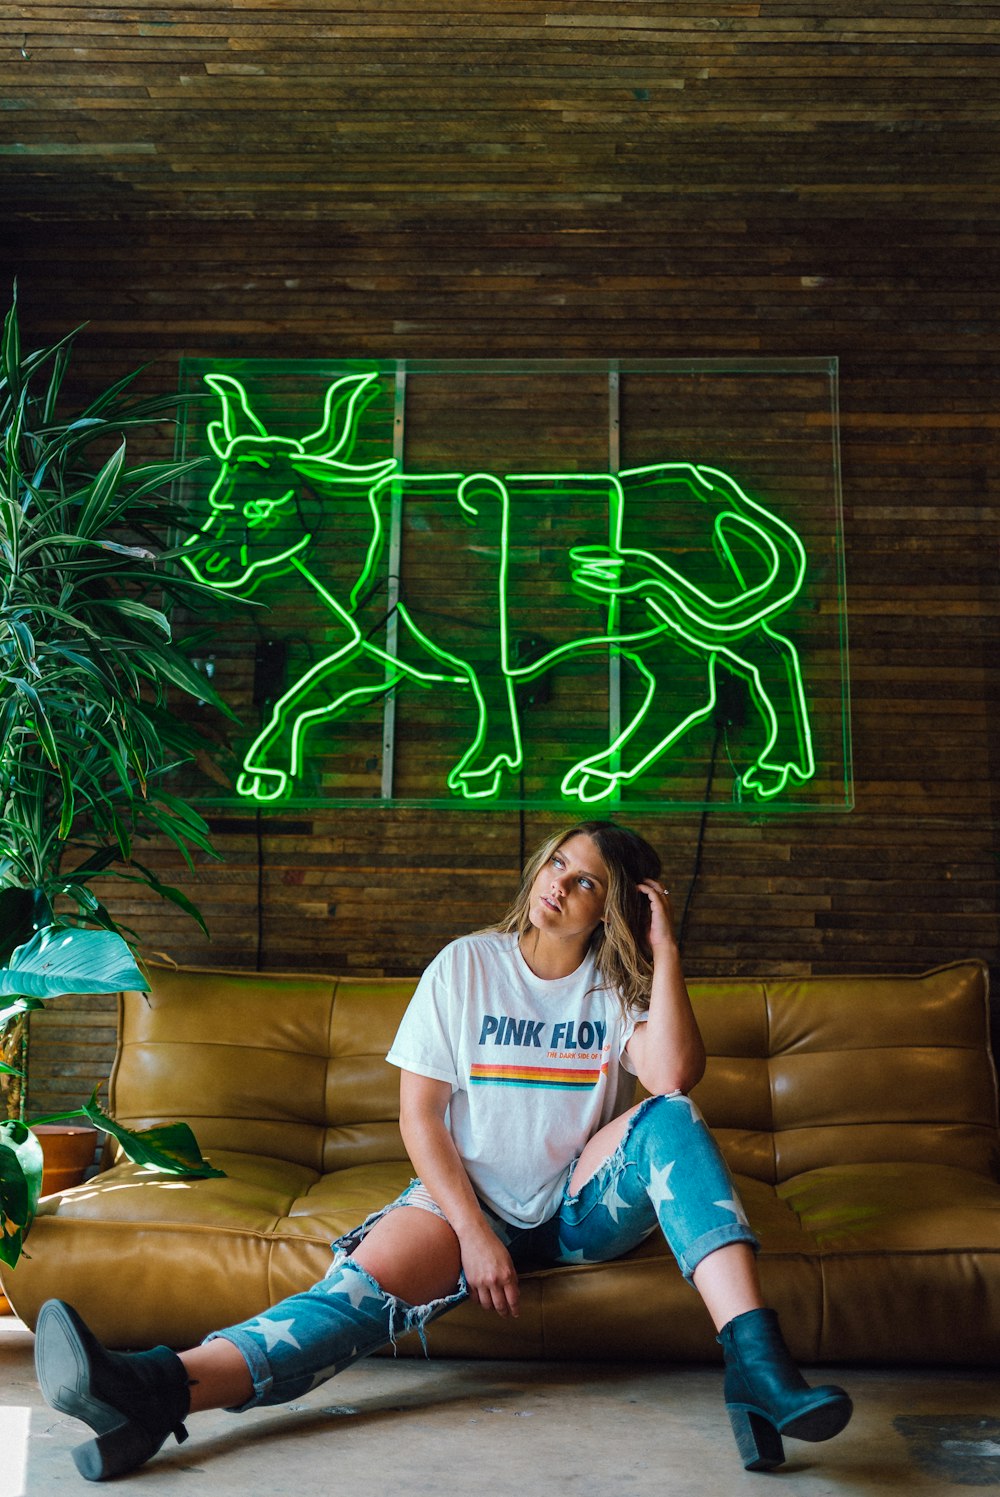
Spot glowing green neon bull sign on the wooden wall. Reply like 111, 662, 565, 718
184, 373, 816, 805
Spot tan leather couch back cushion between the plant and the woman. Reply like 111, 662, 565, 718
109, 967, 416, 1172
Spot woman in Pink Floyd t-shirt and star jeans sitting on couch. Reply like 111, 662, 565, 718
36, 822, 852, 1481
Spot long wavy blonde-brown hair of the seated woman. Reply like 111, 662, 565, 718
490, 822, 662, 1013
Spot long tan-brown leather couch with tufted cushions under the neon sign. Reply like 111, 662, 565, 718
4, 961, 1000, 1364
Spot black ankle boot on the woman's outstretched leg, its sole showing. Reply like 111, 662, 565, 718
34, 1299, 192, 1482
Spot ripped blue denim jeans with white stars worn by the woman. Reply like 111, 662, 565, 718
208, 1093, 757, 1409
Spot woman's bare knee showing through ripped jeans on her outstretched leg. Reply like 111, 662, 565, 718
350, 1207, 461, 1305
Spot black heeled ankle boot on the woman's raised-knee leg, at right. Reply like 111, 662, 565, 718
719, 1310, 852, 1472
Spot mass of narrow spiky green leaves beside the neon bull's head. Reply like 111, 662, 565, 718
0, 284, 245, 952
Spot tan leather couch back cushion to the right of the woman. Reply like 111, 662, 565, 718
690, 961, 1000, 1184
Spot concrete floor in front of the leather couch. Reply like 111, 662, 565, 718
0, 1316, 1000, 1497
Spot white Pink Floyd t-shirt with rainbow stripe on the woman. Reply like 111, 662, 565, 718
388, 933, 645, 1226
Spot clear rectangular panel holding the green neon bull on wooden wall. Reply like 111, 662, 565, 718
181, 359, 852, 816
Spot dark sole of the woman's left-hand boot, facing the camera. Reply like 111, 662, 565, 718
34, 1299, 156, 1482
